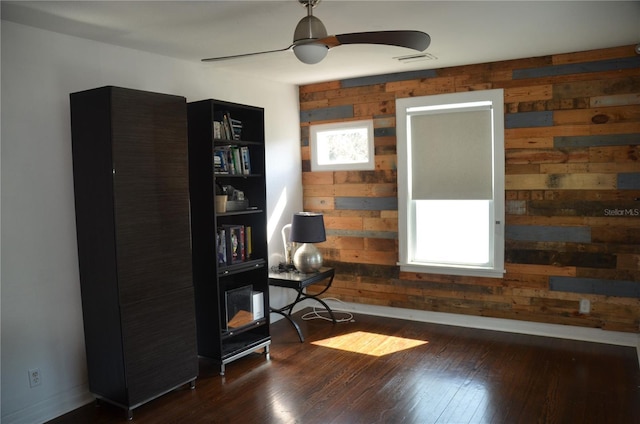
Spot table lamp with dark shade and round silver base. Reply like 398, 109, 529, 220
289, 212, 327, 273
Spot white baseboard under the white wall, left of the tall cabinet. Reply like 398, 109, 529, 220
2, 384, 95, 424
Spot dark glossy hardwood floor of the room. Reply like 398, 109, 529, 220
51, 308, 640, 424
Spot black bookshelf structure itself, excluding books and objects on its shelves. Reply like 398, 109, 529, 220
187, 99, 271, 374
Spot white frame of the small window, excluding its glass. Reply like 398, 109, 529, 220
309, 119, 376, 171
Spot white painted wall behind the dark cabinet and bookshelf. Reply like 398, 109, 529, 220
1, 21, 302, 424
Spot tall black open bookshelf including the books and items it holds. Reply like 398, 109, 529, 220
188, 100, 271, 374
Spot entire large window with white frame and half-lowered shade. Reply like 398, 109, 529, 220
396, 90, 504, 277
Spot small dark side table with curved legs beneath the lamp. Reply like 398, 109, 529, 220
269, 267, 336, 343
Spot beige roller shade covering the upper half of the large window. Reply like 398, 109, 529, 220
409, 107, 493, 200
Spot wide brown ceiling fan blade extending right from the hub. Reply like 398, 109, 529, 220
317, 30, 431, 51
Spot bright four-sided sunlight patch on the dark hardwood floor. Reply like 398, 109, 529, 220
311, 331, 429, 356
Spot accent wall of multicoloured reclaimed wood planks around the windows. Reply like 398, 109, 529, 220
300, 46, 640, 333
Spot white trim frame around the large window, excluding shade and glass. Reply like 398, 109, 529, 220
396, 89, 505, 278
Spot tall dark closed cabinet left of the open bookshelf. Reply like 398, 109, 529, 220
70, 87, 198, 417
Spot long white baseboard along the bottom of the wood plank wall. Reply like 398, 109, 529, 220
296, 299, 640, 366
